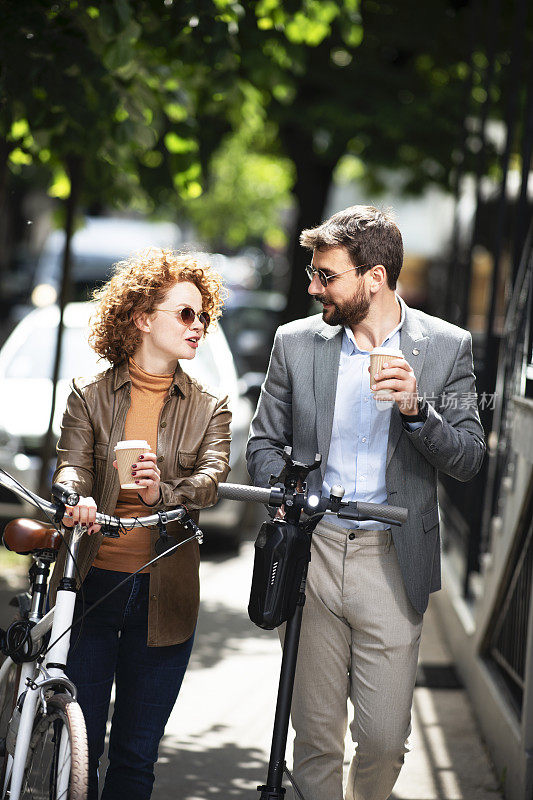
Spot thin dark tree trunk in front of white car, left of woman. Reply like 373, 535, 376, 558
39, 157, 82, 497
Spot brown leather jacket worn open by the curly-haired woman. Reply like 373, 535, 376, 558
52, 362, 231, 646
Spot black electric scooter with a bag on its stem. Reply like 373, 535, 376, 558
218, 447, 408, 800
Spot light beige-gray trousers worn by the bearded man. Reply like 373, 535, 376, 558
281, 522, 423, 800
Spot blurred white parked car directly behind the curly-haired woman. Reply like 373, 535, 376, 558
0, 303, 253, 544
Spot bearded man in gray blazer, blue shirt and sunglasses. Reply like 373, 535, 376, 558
247, 206, 485, 800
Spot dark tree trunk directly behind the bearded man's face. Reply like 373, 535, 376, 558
283, 138, 336, 322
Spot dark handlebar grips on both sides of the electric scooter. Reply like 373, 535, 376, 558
218, 483, 409, 525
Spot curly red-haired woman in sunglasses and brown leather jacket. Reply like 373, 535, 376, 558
54, 249, 230, 800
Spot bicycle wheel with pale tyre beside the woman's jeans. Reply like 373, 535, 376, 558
22, 694, 88, 800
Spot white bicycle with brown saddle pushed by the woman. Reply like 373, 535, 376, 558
0, 471, 203, 800
